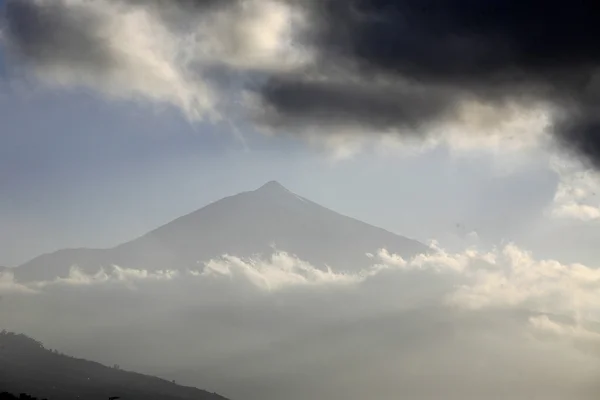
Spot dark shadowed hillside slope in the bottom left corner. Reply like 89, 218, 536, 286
0, 331, 226, 400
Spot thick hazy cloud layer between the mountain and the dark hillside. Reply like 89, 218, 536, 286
0, 245, 600, 400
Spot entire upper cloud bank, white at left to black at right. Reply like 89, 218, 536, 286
3, 0, 600, 166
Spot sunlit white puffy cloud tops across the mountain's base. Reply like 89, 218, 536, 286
7, 243, 600, 320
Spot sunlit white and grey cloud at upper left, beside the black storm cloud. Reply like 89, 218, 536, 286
2, 0, 311, 120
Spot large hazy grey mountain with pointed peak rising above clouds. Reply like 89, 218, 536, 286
14, 181, 429, 281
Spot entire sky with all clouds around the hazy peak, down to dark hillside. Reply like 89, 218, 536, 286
0, 0, 600, 400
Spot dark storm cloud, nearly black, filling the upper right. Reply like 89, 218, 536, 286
264, 0, 600, 167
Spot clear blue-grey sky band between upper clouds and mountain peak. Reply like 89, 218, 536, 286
0, 78, 580, 266
